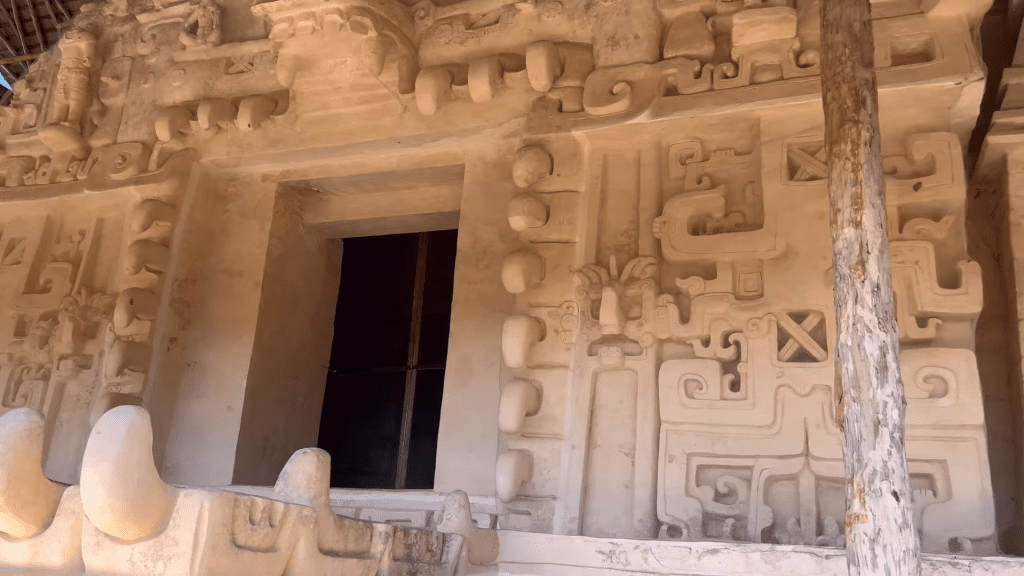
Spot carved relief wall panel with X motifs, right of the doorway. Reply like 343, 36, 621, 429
498, 125, 994, 552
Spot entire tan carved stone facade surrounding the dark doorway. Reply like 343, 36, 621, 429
0, 0, 1024, 575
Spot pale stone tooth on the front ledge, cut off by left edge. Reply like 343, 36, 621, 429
0, 408, 65, 539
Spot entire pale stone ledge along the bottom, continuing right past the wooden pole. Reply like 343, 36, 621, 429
0, 406, 1024, 576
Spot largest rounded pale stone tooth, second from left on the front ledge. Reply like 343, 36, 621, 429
82, 406, 176, 542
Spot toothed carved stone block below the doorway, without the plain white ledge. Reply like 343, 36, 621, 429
0, 406, 498, 576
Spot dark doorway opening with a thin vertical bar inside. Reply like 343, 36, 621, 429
317, 230, 458, 489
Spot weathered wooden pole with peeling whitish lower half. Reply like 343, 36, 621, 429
821, 0, 921, 576
